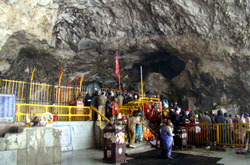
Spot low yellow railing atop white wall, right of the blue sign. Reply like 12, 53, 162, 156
15, 103, 92, 122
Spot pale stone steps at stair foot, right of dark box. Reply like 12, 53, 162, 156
126, 142, 155, 155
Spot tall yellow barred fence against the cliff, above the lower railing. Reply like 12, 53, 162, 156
0, 79, 81, 105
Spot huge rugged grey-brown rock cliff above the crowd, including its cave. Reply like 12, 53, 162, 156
0, 0, 250, 111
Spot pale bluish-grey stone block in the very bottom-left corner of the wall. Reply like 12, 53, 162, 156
0, 150, 17, 165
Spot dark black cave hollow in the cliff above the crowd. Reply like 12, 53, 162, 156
133, 51, 186, 81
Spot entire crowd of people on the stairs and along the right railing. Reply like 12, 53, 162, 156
75, 89, 250, 158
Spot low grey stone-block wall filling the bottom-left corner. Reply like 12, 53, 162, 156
0, 127, 61, 165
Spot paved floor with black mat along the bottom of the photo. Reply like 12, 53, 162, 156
58, 148, 250, 165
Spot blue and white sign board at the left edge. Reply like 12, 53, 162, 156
0, 93, 16, 123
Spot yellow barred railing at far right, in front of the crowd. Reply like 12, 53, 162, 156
186, 123, 250, 146
